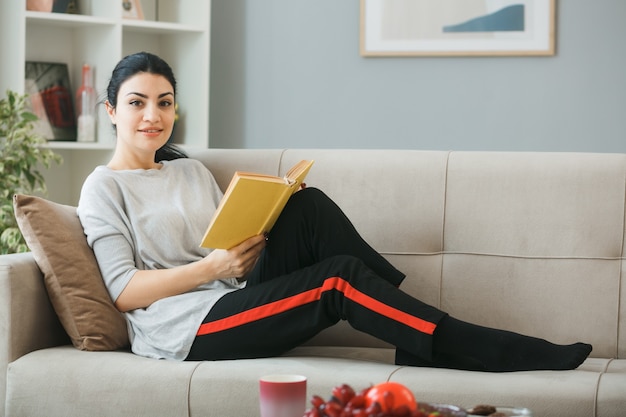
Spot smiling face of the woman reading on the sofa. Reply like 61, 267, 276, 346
106, 72, 176, 156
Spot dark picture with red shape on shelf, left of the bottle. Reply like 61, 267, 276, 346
24, 61, 76, 141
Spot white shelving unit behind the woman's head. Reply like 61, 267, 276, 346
0, 0, 211, 205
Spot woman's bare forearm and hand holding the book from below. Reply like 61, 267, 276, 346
115, 235, 265, 312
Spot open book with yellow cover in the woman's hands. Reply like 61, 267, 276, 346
200, 160, 313, 249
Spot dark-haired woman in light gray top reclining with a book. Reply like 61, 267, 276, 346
78, 52, 591, 372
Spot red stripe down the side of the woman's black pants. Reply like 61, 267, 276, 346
197, 277, 436, 336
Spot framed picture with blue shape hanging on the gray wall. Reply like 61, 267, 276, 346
360, 0, 556, 57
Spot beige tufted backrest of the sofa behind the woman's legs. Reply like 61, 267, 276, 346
191, 149, 626, 358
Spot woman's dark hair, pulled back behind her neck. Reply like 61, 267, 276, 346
106, 52, 187, 162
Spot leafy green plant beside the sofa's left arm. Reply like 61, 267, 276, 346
0, 91, 61, 254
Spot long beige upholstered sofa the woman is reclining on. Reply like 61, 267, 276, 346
0, 150, 626, 417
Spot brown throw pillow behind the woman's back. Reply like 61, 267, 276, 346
13, 195, 129, 350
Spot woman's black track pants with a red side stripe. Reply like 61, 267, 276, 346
187, 188, 445, 360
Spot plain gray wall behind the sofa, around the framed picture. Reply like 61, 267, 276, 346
210, 0, 626, 152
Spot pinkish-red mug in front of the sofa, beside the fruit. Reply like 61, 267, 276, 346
259, 374, 306, 417
